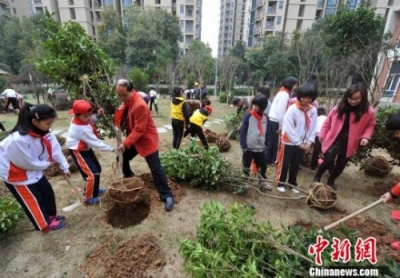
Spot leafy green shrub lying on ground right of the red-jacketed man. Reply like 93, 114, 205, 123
161, 139, 230, 190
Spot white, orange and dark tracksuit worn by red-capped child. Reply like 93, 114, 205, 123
65, 116, 114, 199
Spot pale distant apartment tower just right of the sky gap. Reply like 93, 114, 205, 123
218, 0, 248, 57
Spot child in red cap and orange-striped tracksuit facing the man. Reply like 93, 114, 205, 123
65, 100, 114, 205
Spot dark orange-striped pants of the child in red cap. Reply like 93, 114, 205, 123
69, 150, 101, 199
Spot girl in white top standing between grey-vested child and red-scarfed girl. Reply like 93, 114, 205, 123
266, 76, 298, 164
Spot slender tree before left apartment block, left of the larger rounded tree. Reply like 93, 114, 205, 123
98, 8, 125, 65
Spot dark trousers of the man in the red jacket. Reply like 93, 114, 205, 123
122, 146, 172, 201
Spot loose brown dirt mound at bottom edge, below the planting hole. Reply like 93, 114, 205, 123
81, 235, 166, 278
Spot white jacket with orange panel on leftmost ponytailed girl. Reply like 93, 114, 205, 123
0, 132, 69, 185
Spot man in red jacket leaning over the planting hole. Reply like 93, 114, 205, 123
114, 79, 174, 211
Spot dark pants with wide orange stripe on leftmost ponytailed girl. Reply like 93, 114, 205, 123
4, 176, 57, 231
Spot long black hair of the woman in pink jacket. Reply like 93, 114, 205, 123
338, 83, 369, 122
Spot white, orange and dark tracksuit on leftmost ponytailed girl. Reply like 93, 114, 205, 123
0, 131, 69, 231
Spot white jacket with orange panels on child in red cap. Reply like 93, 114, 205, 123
65, 117, 114, 152
